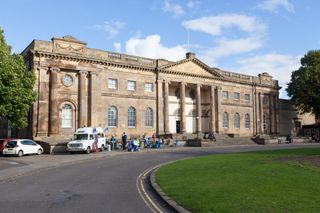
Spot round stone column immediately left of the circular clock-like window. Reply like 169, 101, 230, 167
49, 67, 60, 136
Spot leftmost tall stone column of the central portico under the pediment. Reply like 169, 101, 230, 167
156, 80, 164, 135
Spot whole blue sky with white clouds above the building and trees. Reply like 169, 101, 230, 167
0, 0, 320, 98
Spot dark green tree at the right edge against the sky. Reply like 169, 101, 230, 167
287, 50, 320, 117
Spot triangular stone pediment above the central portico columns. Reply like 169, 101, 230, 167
161, 58, 222, 78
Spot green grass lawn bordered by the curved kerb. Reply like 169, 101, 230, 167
156, 148, 320, 213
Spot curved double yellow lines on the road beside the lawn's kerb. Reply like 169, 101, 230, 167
136, 166, 163, 213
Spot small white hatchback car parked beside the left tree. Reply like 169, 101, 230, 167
3, 139, 43, 157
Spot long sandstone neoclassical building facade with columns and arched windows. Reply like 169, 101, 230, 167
22, 36, 280, 139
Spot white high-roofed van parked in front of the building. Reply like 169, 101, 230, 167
67, 127, 106, 154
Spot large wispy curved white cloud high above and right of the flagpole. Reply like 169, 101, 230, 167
182, 14, 267, 65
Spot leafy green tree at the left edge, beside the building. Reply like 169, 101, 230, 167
0, 28, 36, 128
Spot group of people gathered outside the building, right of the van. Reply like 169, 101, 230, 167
109, 132, 164, 152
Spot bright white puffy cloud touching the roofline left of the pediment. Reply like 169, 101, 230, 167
126, 35, 187, 61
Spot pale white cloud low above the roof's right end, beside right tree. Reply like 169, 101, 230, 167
232, 53, 300, 98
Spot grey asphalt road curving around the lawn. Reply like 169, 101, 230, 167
0, 144, 319, 213
